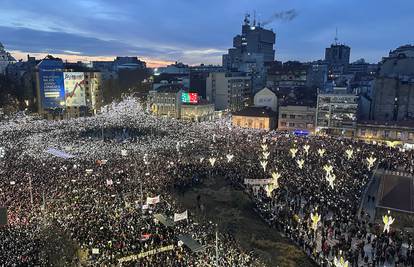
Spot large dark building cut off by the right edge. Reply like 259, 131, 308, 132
371, 45, 414, 122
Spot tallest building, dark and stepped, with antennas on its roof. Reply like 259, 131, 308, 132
223, 15, 276, 94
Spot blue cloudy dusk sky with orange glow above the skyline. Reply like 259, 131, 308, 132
0, 0, 414, 66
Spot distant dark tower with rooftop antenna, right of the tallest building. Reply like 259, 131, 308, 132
325, 42, 351, 75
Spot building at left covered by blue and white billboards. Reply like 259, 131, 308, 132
36, 56, 103, 119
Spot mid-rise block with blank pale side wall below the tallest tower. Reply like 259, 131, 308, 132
206, 72, 252, 111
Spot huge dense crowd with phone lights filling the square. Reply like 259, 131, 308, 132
0, 98, 414, 266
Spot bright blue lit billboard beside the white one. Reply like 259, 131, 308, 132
39, 69, 65, 108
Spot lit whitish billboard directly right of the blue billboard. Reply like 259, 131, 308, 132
63, 72, 86, 107
